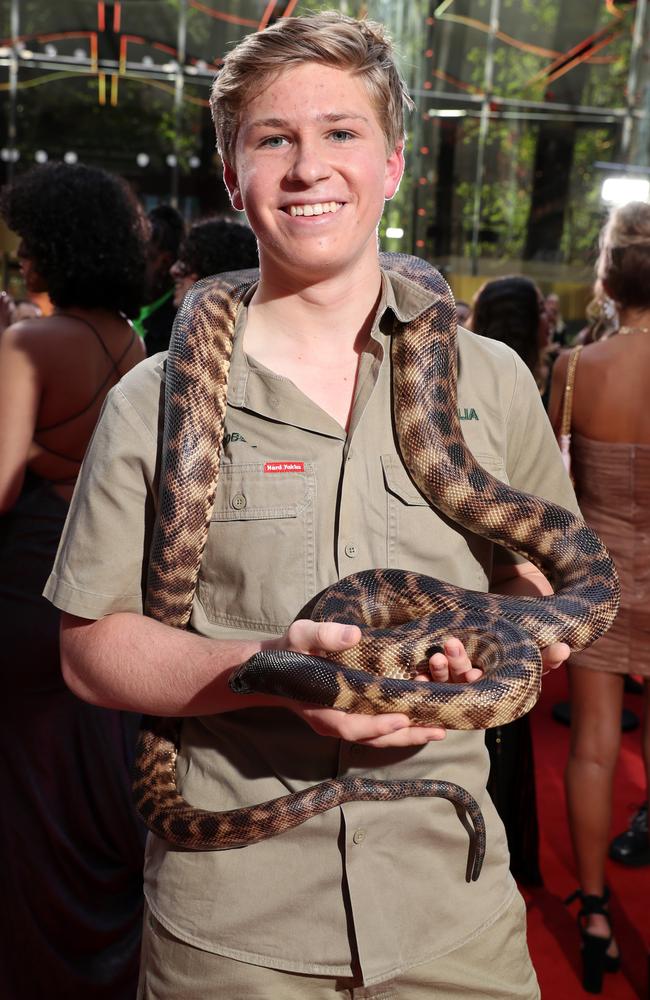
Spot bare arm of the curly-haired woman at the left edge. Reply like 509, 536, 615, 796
0, 320, 41, 513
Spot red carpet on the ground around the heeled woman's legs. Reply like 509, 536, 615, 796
522, 669, 650, 1000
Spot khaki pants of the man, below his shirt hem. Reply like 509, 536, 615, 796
138, 893, 540, 1000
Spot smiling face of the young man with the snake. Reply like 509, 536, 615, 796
224, 63, 404, 284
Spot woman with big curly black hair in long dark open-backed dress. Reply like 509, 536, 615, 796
0, 163, 145, 1000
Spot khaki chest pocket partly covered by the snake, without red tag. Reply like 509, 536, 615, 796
381, 454, 507, 590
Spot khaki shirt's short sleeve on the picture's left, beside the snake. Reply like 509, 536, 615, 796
43, 362, 160, 619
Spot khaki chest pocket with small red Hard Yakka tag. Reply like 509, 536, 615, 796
197, 463, 315, 632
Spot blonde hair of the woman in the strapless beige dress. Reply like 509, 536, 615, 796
596, 201, 650, 306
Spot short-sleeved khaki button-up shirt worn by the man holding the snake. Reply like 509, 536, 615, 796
46, 275, 576, 984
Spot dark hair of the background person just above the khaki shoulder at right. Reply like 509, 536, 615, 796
472, 274, 540, 375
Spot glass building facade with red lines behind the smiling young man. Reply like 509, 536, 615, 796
0, 0, 650, 315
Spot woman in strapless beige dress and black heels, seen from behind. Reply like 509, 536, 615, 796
549, 202, 650, 993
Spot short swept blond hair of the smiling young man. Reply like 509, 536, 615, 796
210, 11, 414, 165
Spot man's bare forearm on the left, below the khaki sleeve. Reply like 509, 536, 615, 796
61, 613, 264, 716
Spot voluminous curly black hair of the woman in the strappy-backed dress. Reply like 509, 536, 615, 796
0, 163, 148, 316
